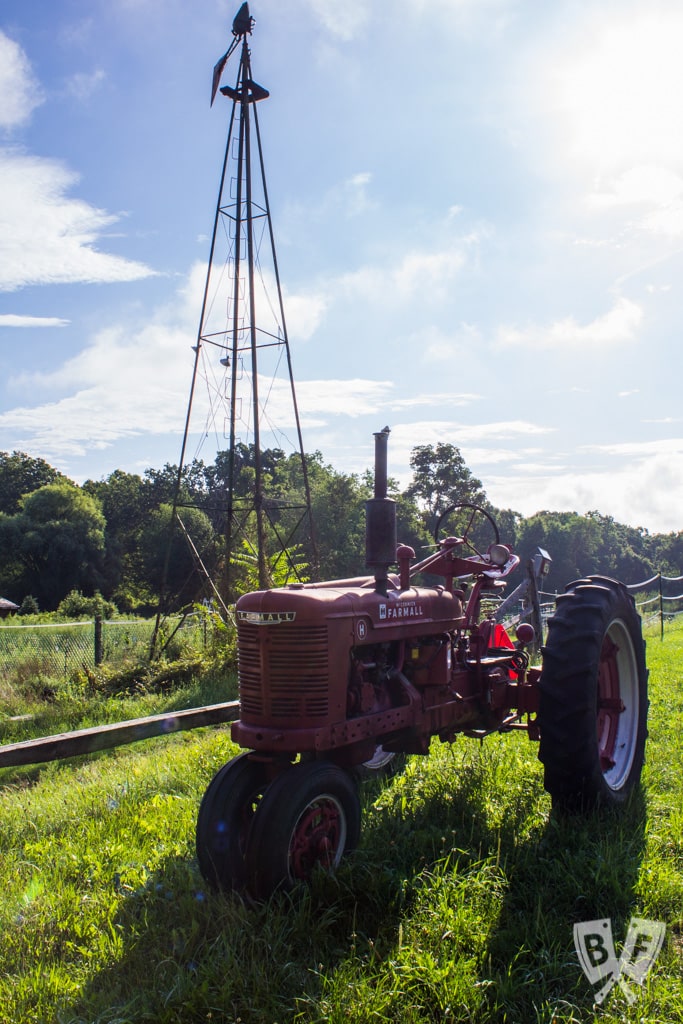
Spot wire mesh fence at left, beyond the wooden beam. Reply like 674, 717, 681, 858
0, 620, 204, 679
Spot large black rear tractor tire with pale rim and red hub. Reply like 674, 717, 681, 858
539, 577, 648, 811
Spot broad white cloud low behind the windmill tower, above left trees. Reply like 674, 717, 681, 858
0, 262, 394, 460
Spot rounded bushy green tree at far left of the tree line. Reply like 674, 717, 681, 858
0, 483, 104, 610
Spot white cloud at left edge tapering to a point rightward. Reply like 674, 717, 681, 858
0, 150, 154, 292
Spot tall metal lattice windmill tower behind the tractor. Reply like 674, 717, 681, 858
162, 3, 316, 618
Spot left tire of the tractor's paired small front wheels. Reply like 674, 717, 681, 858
196, 753, 268, 891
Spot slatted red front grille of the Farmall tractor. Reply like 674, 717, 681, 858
238, 623, 329, 727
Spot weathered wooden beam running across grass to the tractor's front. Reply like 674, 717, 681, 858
0, 700, 240, 768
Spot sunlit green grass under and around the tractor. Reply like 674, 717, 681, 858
0, 626, 683, 1024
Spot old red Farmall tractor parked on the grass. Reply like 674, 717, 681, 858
197, 428, 647, 898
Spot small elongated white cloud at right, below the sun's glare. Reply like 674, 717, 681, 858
497, 298, 643, 352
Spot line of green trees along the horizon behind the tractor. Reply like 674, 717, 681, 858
0, 442, 683, 614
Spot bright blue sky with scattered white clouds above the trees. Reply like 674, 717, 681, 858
0, 0, 683, 531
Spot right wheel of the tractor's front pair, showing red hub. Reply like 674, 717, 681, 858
246, 761, 360, 899
